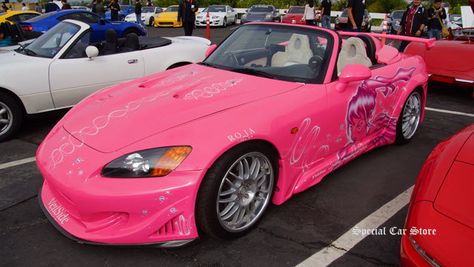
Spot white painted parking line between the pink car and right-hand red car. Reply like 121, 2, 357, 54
297, 186, 413, 267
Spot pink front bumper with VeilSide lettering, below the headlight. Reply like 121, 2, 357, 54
37, 126, 205, 247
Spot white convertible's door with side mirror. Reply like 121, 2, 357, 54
49, 31, 144, 108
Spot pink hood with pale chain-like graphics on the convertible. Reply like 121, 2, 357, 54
63, 65, 302, 152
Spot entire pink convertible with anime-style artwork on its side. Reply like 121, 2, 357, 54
37, 23, 430, 246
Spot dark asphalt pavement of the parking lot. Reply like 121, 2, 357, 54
0, 26, 474, 266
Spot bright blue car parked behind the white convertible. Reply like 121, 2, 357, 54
20, 9, 146, 41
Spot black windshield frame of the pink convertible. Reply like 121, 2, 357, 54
200, 23, 338, 84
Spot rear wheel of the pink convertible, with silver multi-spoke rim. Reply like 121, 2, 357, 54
396, 89, 423, 144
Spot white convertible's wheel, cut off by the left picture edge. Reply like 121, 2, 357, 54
0, 92, 23, 142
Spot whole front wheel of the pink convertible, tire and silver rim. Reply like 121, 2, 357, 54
196, 143, 278, 239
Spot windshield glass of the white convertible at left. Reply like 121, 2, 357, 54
19, 22, 81, 58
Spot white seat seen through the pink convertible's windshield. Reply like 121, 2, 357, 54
272, 33, 313, 67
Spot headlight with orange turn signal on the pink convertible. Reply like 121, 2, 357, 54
101, 146, 192, 178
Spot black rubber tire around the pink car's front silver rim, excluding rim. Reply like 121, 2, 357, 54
196, 143, 278, 239
